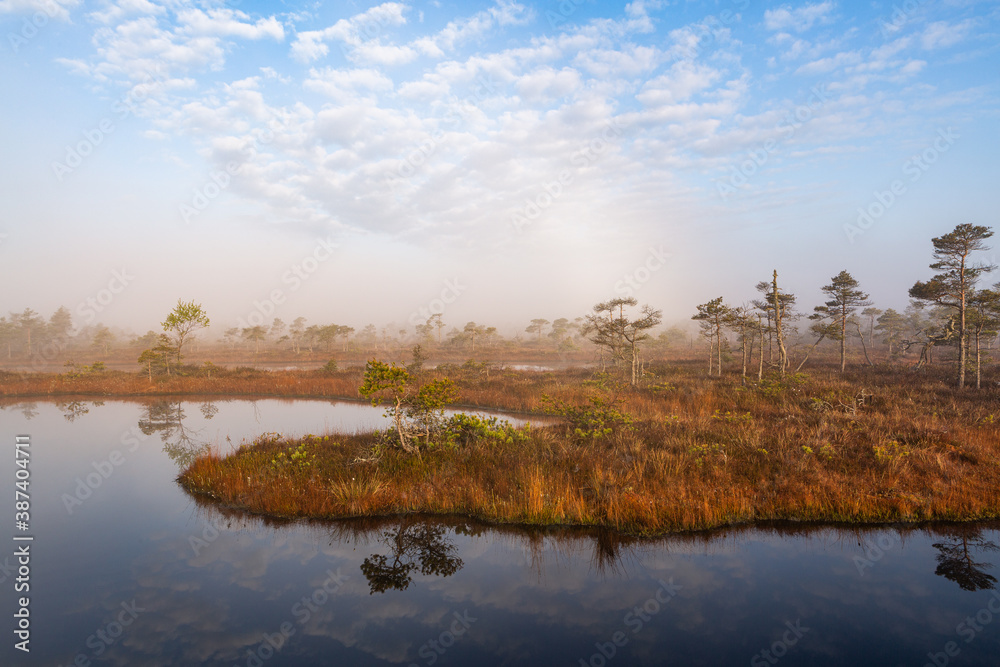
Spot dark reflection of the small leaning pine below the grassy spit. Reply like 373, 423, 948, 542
361, 521, 464, 594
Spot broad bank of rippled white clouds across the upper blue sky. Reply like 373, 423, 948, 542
45, 0, 992, 253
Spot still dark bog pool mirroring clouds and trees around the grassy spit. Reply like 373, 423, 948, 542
0, 398, 1000, 667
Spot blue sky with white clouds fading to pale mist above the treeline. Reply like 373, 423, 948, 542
0, 0, 1000, 335
